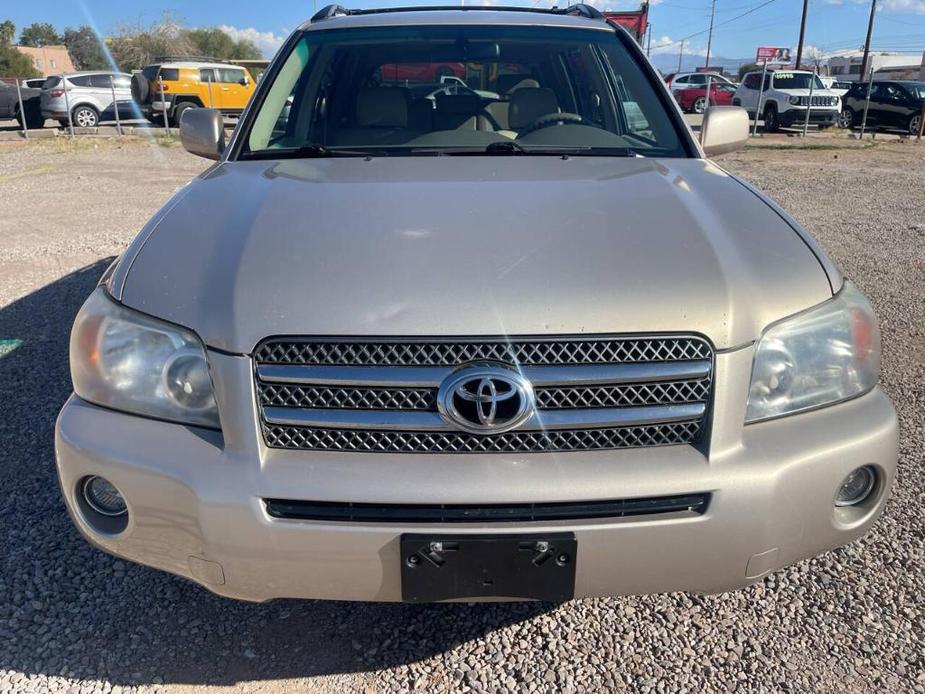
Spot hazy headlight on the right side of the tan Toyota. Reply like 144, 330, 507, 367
745, 282, 880, 422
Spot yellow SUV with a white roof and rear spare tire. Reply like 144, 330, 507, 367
132, 60, 255, 126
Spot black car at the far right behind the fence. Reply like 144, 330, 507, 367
839, 81, 925, 135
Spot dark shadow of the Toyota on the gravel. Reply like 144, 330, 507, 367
0, 260, 555, 686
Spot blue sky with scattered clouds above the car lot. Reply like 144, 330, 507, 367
7, 0, 925, 58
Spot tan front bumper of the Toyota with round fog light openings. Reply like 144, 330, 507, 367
56, 348, 897, 601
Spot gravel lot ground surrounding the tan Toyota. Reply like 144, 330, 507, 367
0, 140, 925, 692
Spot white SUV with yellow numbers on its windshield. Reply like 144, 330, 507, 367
732, 70, 841, 133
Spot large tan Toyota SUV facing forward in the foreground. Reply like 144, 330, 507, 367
56, 5, 898, 602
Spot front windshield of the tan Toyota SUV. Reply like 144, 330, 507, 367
241, 26, 686, 158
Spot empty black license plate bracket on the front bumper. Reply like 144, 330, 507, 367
400, 532, 578, 602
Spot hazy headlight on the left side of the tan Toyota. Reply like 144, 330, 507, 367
71, 287, 219, 428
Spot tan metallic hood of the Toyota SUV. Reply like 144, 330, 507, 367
114, 156, 832, 353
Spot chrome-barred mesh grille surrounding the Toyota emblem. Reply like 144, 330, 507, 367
254, 336, 713, 453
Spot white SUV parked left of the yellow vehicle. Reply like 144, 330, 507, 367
42, 71, 137, 128
